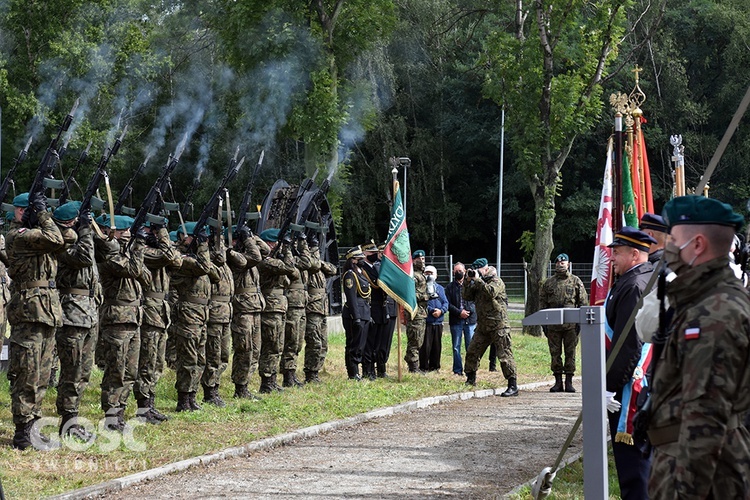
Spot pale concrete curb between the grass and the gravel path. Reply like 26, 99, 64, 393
50, 381, 550, 500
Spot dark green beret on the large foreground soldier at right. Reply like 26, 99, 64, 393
662, 195, 745, 230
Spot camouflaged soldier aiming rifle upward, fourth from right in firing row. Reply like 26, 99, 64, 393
227, 226, 271, 399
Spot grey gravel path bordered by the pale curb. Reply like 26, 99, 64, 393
107, 385, 581, 499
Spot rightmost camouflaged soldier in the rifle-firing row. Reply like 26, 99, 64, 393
304, 237, 338, 383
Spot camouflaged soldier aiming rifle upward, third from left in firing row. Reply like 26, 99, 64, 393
96, 215, 151, 432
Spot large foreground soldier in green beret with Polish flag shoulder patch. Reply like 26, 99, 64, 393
648, 196, 750, 499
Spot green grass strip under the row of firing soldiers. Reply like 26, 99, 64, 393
0, 313, 600, 498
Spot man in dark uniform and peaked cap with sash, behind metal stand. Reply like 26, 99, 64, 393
605, 226, 656, 499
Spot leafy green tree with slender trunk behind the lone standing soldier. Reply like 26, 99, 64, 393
485, 0, 664, 335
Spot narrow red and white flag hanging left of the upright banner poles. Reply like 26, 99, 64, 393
589, 137, 614, 306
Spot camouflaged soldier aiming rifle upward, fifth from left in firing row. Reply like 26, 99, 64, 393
172, 222, 211, 411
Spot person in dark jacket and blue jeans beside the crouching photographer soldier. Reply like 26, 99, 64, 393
445, 262, 477, 375
